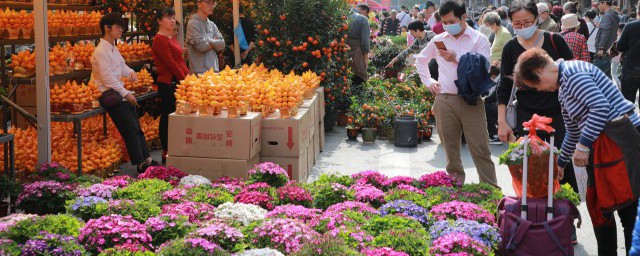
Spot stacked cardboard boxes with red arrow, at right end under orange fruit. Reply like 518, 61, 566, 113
260, 108, 316, 182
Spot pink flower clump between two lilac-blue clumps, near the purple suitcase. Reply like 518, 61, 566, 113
430, 201, 495, 225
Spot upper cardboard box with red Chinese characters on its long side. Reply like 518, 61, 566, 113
169, 111, 262, 160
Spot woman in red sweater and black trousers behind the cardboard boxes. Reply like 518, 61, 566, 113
152, 8, 189, 163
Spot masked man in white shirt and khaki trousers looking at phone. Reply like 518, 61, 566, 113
416, 0, 498, 186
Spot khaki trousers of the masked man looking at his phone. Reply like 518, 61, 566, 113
433, 94, 498, 187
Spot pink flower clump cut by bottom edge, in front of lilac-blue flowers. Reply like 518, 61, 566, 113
429, 233, 491, 256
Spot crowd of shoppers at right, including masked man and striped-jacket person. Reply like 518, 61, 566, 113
362, 0, 640, 255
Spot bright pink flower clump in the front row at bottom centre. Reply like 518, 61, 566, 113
251, 219, 320, 254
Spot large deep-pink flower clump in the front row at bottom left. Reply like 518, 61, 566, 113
78, 215, 151, 253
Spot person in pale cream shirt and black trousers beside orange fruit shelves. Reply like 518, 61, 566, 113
91, 13, 157, 173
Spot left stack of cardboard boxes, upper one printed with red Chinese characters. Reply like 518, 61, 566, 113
167, 112, 262, 179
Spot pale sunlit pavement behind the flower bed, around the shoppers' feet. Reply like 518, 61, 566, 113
309, 128, 625, 255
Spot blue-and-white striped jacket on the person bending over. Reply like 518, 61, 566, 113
558, 60, 640, 167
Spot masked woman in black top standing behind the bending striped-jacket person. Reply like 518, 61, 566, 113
497, 2, 578, 243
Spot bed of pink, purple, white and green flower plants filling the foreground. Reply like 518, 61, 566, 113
0, 163, 580, 256
